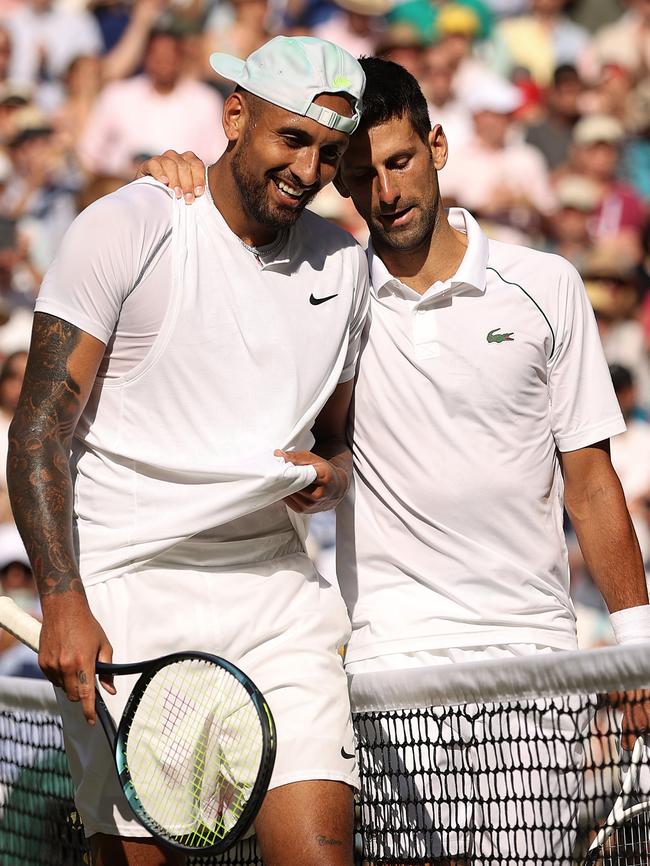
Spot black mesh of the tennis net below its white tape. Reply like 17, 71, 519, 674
0, 676, 650, 866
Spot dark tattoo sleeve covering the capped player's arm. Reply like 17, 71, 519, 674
7, 313, 83, 596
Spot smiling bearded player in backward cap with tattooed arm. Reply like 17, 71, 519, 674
9, 37, 368, 866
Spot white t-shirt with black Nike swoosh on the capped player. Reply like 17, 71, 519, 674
36, 181, 368, 583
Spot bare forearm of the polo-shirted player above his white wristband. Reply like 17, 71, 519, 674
566, 475, 648, 613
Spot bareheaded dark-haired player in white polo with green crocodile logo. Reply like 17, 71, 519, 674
144, 58, 650, 864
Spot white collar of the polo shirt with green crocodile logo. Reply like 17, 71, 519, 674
366, 207, 488, 301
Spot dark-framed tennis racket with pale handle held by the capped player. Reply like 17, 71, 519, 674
0, 597, 276, 854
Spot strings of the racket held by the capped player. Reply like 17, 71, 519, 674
121, 659, 263, 848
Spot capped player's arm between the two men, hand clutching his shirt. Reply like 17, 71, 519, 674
275, 379, 354, 514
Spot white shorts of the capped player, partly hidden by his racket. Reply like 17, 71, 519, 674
56, 553, 359, 837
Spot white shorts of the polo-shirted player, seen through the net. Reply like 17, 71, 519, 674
347, 644, 590, 866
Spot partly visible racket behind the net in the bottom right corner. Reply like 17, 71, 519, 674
585, 737, 650, 866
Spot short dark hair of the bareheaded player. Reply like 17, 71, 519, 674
359, 57, 431, 143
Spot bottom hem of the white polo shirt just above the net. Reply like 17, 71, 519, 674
345, 628, 578, 664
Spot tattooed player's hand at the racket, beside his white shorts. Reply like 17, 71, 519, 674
38, 591, 115, 725
